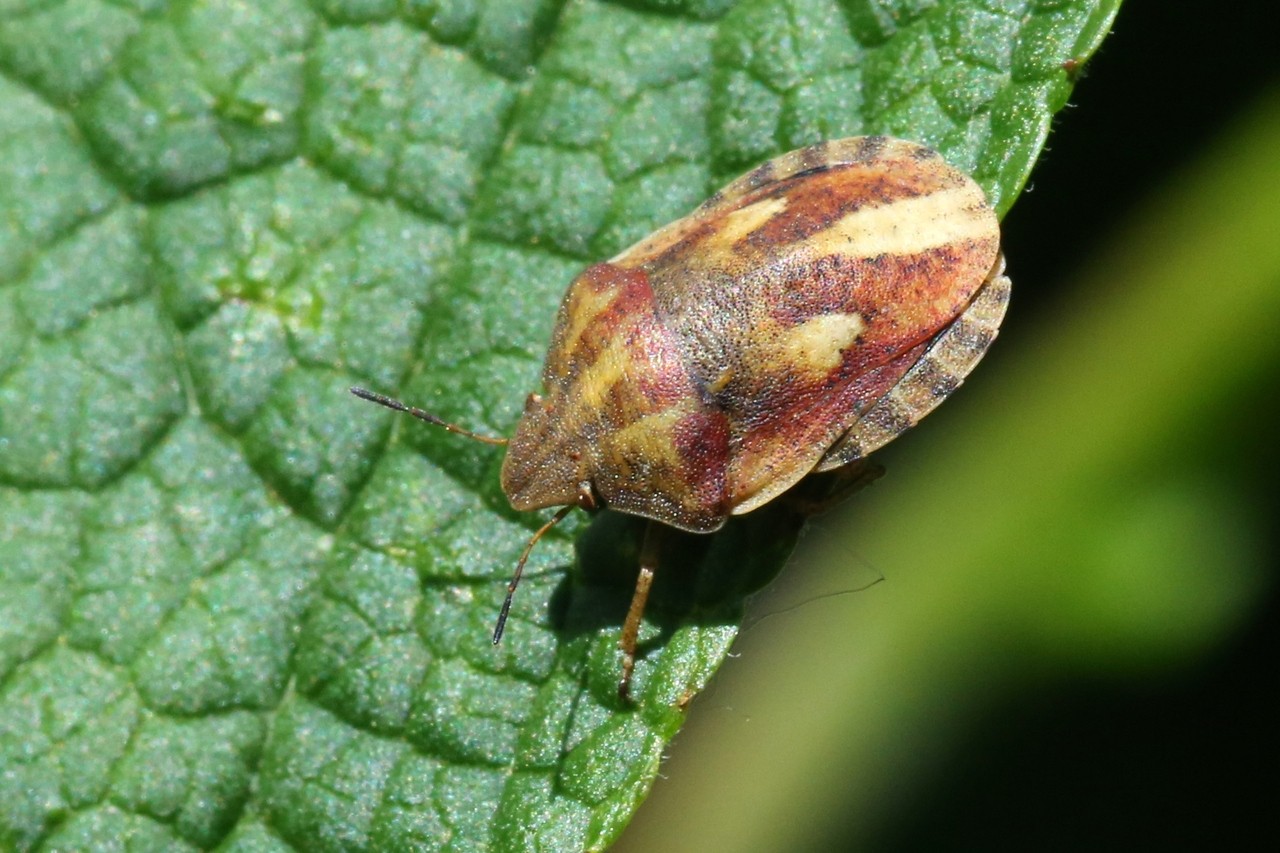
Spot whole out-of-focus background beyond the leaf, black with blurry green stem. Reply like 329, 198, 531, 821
617, 1, 1280, 850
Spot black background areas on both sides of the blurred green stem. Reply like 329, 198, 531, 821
859, 0, 1280, 850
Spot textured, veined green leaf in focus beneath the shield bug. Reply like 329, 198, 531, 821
0, 0, 1117, 850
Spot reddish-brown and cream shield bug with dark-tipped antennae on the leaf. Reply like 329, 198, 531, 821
352, 136, 1010, 695
